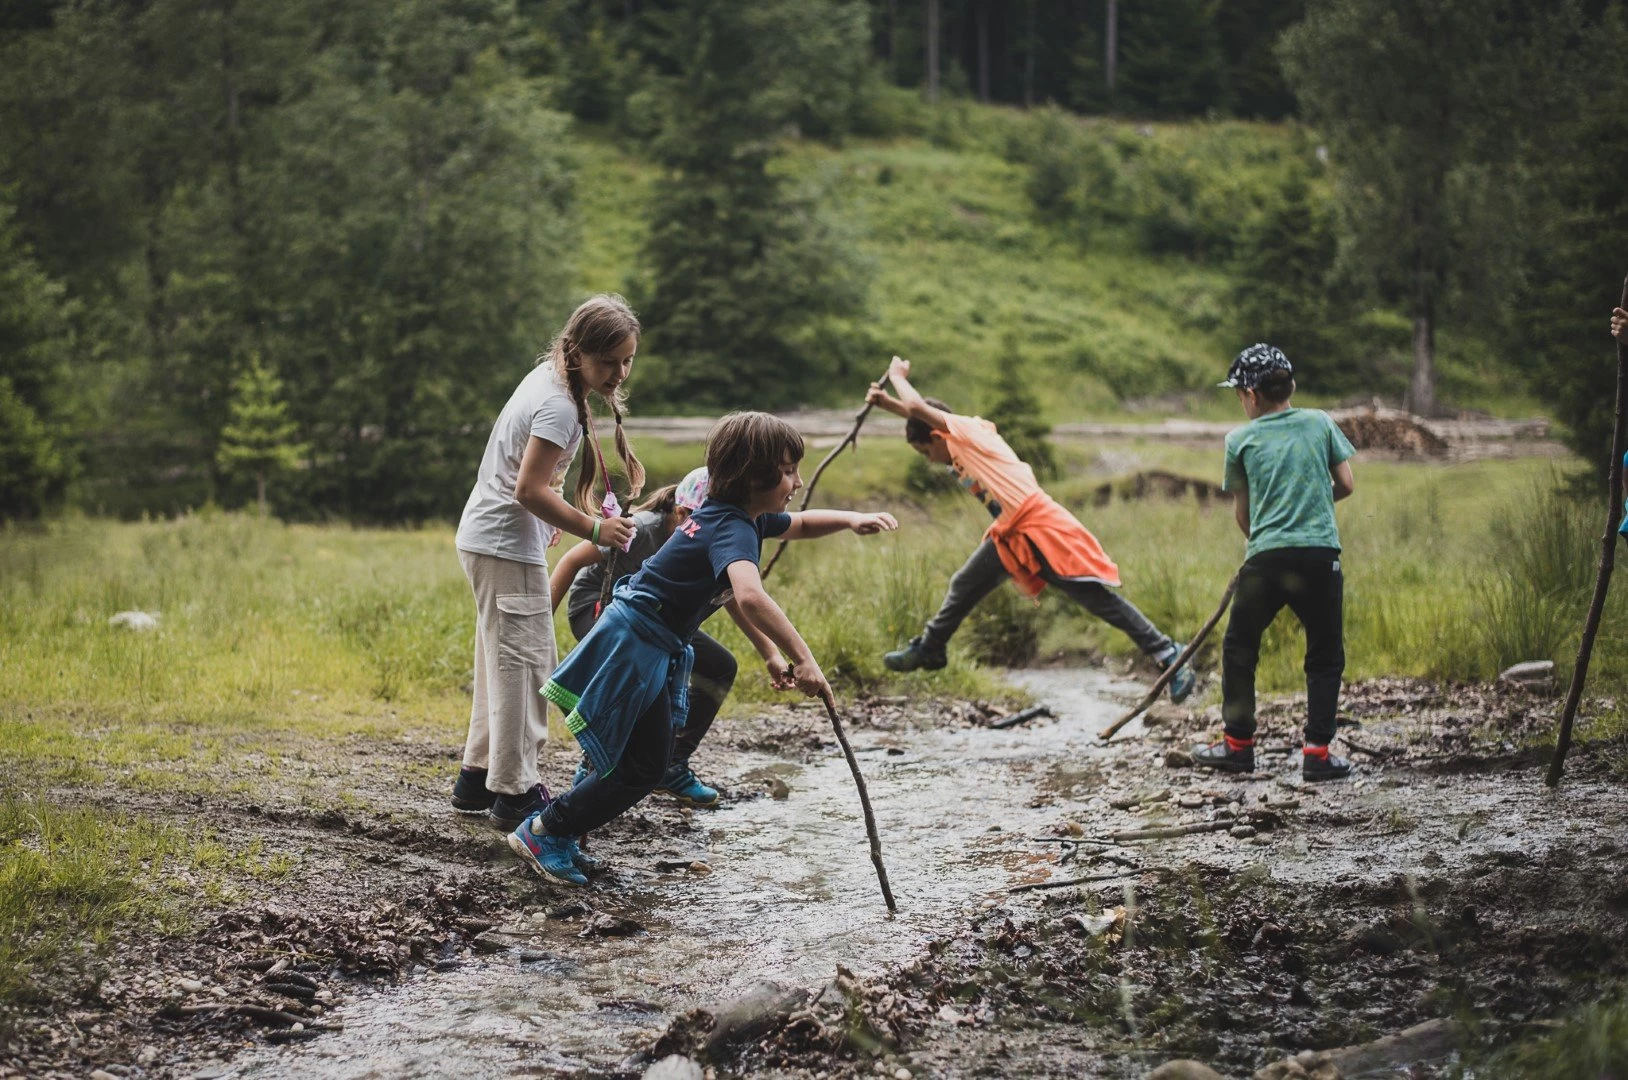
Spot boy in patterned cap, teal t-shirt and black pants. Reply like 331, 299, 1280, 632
1193, 344, 1356, 780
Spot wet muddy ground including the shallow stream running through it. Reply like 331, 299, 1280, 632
0, 670, 1628, 1077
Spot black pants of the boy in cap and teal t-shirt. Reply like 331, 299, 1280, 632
1221, 547, 1345, 746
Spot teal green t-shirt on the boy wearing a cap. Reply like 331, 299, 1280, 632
1221, 409, 1356, 557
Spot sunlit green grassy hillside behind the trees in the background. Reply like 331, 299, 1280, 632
576, 103, 1540, 422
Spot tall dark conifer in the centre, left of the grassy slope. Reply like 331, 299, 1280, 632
638, 0, 868, 407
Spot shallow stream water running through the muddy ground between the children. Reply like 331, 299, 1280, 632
208, 671, 1131, 1078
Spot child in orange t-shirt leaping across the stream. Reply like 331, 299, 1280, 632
866, 357, 1197, 702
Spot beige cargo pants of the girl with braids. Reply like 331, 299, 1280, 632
457, 551, 555, 795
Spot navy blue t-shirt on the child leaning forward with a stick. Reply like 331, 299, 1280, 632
628, 498, 791, 639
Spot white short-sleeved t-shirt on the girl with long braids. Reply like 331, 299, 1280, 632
457, 360, 583, 567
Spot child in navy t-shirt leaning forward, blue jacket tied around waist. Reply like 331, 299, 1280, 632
510, 412, 899, 885
